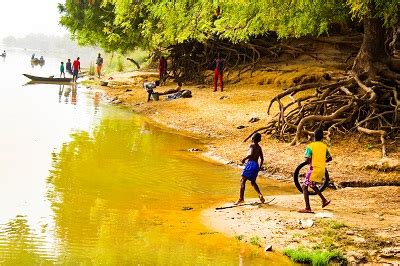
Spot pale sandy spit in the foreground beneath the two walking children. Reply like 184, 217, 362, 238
203, 187, 400, 263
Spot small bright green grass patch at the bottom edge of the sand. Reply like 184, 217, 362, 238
283, 247, 345, 266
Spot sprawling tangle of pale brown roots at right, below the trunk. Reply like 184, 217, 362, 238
245, 70, 400, 157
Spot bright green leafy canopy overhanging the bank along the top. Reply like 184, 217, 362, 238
59, 0, 400, 53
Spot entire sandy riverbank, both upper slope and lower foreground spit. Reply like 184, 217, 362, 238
83, 55, 400, 262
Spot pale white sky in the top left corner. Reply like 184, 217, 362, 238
0, 0, 67, 39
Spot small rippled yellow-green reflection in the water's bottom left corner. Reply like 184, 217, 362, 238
0, 216, 46, 265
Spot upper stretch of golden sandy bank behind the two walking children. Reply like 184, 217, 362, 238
93, 65, 400, 186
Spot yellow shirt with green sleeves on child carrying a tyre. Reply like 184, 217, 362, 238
305, 141, 331, 183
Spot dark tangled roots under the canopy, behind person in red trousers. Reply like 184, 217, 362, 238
168, 37, 322, 83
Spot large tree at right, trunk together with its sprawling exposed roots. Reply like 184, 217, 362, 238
252, 0, 400, 156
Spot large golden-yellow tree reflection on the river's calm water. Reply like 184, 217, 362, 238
48, 117, 230, 265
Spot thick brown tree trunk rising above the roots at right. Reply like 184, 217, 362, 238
352, 16, 388, 77
